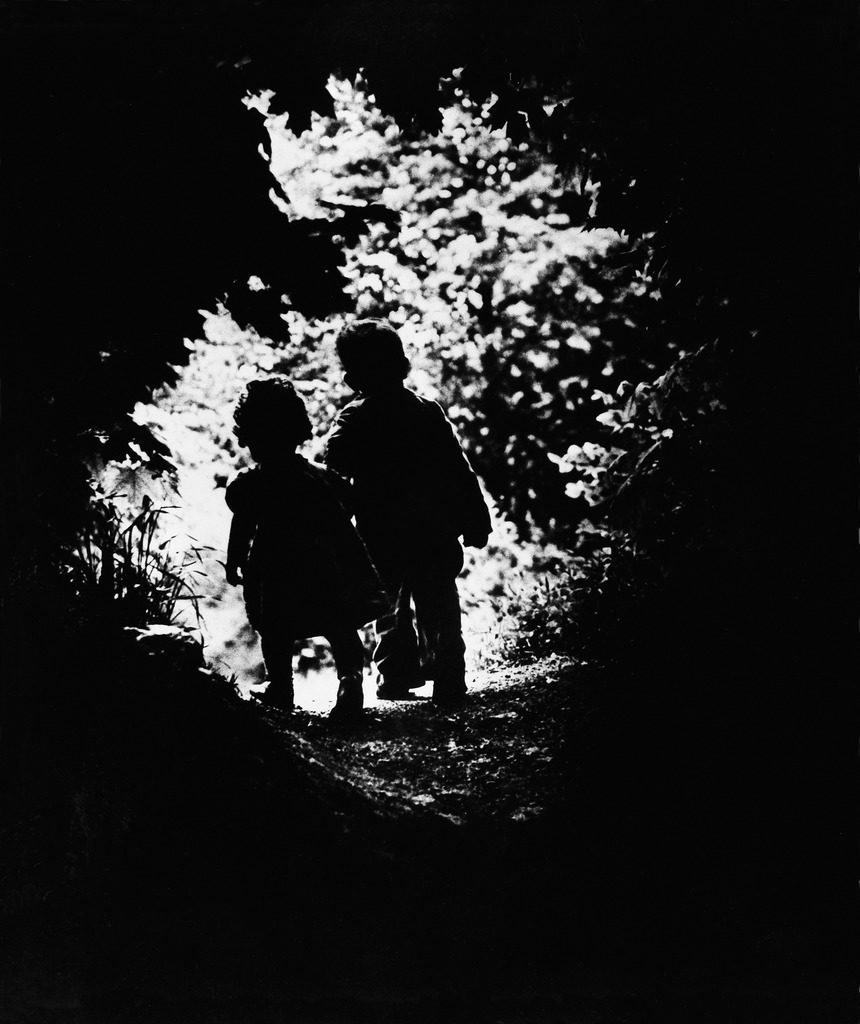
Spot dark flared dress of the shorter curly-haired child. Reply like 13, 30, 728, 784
226, 453, 385, 640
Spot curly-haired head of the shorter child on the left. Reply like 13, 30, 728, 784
233, 374, 312, 461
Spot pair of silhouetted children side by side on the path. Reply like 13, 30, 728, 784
226, 321, 490, 719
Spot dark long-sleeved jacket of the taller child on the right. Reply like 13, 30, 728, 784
326, 386, 490, 557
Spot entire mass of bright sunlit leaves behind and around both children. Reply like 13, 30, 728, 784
129, 74, 670, 671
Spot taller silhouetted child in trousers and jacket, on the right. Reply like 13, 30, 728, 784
326, 319, 490, 703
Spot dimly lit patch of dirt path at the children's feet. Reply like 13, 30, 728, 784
254, 657, 572, 824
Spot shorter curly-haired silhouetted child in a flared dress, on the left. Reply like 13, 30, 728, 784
226, 376, 384, 718
